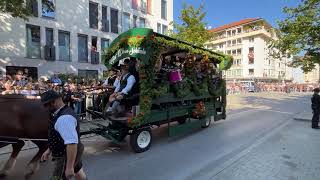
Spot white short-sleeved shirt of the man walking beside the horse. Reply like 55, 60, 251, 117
54, 106, 79, 145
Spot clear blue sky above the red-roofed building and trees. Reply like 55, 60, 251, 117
173, 0, 303, 82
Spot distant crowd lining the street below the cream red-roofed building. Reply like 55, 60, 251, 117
227, 82, 319, 94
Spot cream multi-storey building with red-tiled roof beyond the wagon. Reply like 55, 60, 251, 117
206, 18, 293, 82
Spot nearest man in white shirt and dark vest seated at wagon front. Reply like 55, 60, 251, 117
107, 58, 136, 114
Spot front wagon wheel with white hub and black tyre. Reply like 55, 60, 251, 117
130, 128, 152, 153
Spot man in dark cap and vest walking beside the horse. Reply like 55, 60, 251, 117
41, 90, 86, 180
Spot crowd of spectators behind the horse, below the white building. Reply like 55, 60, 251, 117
0, 73, 103, 118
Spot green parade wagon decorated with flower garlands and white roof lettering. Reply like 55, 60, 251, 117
84, 28, 232, 152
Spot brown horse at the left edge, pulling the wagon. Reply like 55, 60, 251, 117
0, 95, 49, 179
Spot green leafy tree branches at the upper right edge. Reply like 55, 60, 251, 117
271, 0, 320, 72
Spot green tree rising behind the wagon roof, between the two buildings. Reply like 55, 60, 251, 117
170, 3, 212, 47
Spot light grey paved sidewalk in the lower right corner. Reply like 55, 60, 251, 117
210, 120, 320, 180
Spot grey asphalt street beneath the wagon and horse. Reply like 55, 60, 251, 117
0, 93, 310, 180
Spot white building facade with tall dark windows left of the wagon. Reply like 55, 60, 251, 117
0, 0, 173, 78
